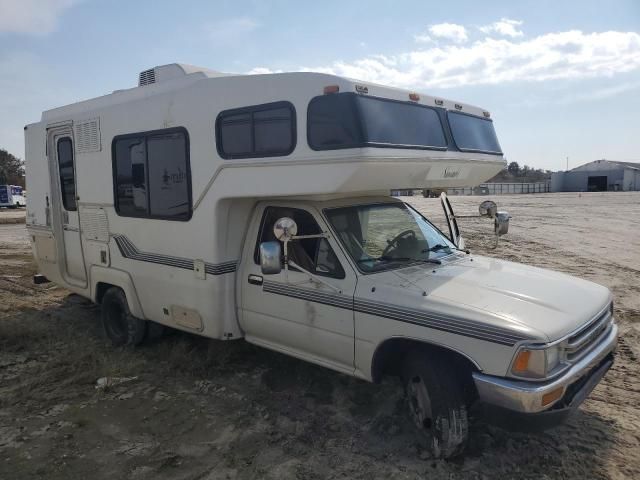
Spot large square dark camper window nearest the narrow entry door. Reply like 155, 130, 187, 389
112, 128, 192, 221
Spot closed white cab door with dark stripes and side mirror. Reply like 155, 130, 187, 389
239, 206, 356, 373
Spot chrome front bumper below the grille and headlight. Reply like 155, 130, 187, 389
473, 323, 618, 414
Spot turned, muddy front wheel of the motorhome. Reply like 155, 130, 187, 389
403, 351, 469, 458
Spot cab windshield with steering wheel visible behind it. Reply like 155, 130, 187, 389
325, 203, 455, 273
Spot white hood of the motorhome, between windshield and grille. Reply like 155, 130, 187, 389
358, 255, 611, 342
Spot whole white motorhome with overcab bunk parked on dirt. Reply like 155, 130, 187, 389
25, 64, 617, 457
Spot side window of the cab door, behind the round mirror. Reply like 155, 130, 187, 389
254, 207, 345, 278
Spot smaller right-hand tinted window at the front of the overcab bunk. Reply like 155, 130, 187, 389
447, 112, 502, 153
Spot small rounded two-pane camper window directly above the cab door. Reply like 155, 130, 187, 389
216, 102, 296, 159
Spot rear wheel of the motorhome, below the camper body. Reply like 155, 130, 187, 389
101, 287, 147, 347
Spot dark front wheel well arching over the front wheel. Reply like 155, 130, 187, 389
371, 338, 479, 401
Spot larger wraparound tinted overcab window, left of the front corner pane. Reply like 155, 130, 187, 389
307, 92, 447, 150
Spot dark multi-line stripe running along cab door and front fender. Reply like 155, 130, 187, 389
262, 282, 530, 346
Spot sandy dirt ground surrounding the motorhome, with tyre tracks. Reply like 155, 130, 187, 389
0, 193, 640, 480
